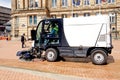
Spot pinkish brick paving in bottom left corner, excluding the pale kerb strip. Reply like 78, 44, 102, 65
0, 67, 55, 80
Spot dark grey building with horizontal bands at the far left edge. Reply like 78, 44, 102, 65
0, 6, 11, 31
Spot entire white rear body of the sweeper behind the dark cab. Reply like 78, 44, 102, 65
63, 16, 109, 47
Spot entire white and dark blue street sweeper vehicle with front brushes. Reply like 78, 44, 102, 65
17, 15, 113, 65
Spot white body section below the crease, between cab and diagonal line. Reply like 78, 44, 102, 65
64, 24, 101, 46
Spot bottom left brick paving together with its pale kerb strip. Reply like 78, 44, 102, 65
0, 66, 94, 80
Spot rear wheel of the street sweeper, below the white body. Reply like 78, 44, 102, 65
91, 49, 107, 65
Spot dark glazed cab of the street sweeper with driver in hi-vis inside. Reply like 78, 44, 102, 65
34, 19, 62, 49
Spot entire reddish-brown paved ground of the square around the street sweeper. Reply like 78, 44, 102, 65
0, 40, 120, 80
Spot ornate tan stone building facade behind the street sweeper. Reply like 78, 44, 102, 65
12, 0, 120, 38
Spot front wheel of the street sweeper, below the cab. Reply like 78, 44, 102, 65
45, 48, 58, 62
